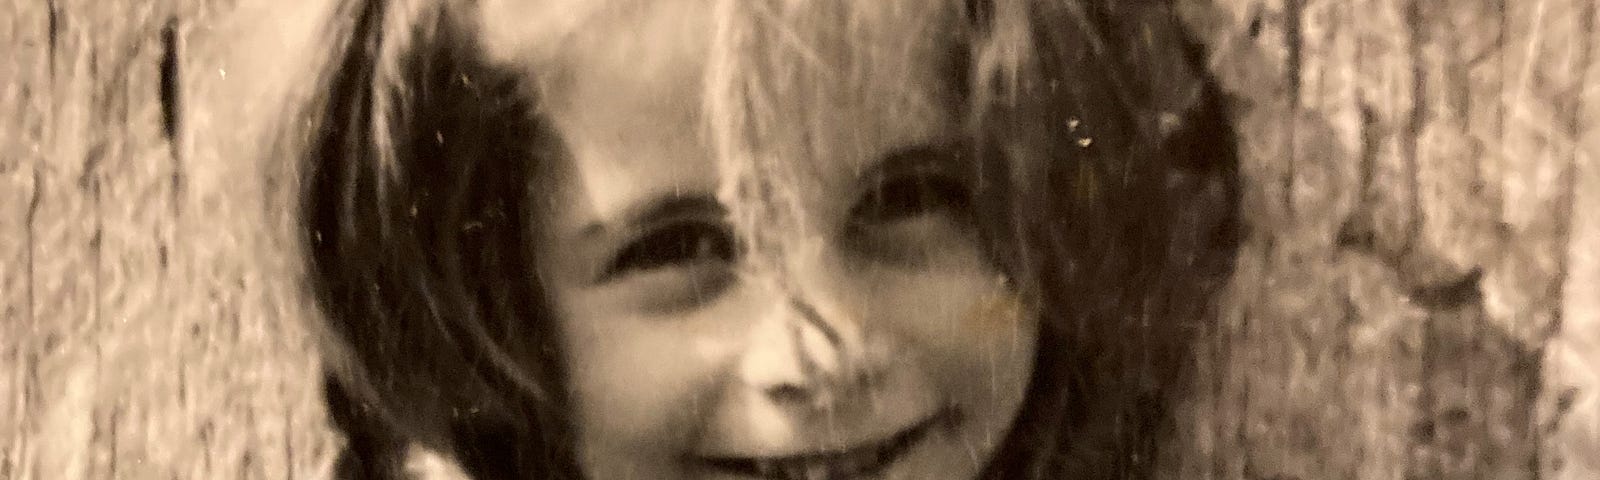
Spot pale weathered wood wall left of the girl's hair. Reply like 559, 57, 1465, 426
0, 0, 334, 478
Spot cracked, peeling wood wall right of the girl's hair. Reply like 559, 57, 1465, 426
1170, 0, 1600, 478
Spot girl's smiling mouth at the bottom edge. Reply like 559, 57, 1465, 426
696, 411, 958, 480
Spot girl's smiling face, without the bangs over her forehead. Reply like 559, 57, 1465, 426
502, 2, 1037, 478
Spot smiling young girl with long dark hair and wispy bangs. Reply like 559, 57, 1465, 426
304, 0, 1235, 478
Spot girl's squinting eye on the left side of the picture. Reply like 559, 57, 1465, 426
603, 221, 738, 278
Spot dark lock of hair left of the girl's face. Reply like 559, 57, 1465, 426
304, 2, 571, 478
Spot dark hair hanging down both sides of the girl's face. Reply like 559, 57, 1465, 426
302, 0, 1238, 478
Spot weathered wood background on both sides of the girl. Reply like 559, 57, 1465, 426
0, 0, 1600, 480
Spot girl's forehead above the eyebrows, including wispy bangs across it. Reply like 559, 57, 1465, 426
480, 0, 955, 232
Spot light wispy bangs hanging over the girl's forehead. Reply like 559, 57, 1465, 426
702, 0, 970, 259
